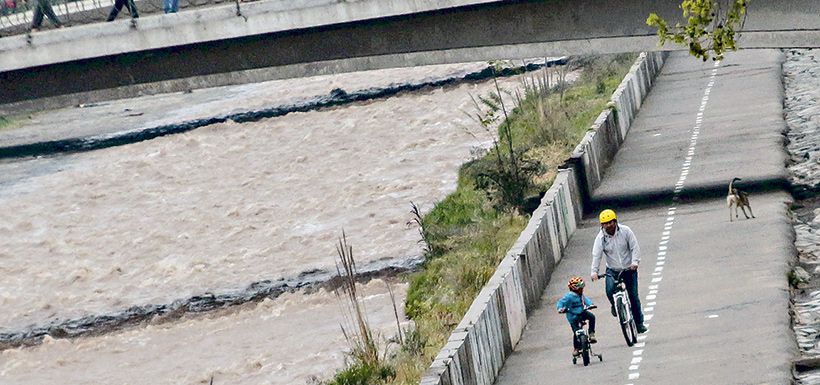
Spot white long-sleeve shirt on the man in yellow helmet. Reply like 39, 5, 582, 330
592, 224, 641, 274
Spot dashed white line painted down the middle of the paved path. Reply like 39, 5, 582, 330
626, 61, 720, 385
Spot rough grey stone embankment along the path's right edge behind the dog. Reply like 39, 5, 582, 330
783, 50, 820, 384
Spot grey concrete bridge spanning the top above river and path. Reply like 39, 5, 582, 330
0, 0, 820, 110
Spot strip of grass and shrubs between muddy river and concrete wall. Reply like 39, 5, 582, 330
330, 54, 636, 385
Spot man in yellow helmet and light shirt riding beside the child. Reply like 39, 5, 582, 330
590, 209, 646, 333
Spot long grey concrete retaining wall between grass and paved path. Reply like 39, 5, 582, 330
421, 52, 666, 385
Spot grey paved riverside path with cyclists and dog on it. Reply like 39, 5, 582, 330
496, 50, 795, 385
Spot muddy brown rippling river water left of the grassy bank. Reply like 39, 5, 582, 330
0, 63, 556, 384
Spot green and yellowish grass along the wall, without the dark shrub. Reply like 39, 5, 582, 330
326, 55, 636, 384
